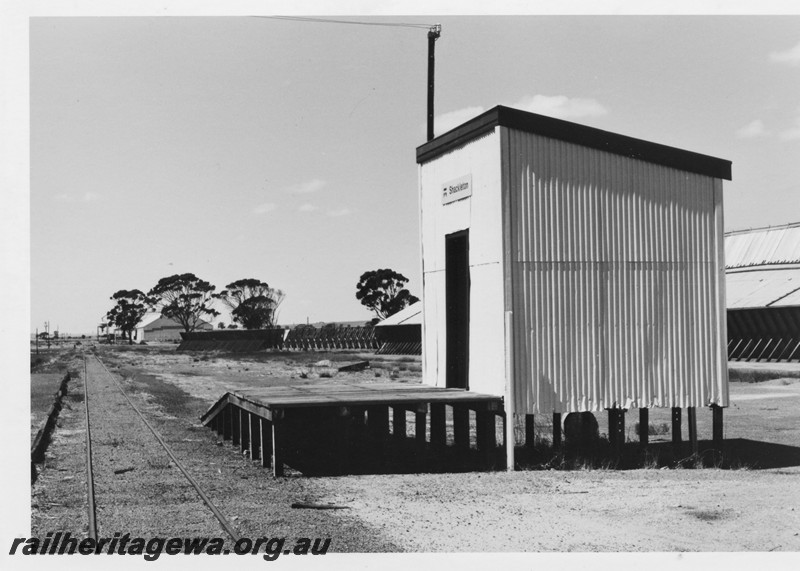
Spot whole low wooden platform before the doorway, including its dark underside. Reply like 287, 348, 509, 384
201, 383, 505, 476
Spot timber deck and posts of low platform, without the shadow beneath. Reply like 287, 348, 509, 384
201, 383, 503, 476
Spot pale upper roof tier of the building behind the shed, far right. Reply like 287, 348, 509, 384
725, 222, 800, 268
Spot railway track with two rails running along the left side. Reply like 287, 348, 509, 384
83, 355, 240, 543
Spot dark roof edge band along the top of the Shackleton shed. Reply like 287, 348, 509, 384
417, 105, 731, 180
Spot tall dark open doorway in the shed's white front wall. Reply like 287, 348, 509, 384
445, 230, 469, 389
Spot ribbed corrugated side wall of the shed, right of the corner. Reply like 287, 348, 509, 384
504, 127, 728, 414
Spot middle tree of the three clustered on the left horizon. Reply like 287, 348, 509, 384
149, 274, 219, 333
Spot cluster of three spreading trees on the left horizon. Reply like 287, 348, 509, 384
106, 273, 285, 343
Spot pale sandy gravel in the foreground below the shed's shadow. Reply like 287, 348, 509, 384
310, 468, 800, 552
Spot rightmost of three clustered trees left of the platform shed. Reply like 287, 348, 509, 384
219, 278, 285, 329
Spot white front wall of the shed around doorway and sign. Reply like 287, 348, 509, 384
419, 129, 505, 395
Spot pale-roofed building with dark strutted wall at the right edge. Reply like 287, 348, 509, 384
725, 222, 800, 361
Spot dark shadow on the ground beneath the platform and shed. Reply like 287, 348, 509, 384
270, 432, 800, 476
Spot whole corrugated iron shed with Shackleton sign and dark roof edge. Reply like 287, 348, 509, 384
417, 107, 731, 414
